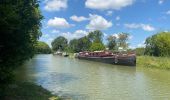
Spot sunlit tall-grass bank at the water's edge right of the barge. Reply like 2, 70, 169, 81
137, 56, 170, 69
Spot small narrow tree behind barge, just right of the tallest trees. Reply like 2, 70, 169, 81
107, 35, 117, 50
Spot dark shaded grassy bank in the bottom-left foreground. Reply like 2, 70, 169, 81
3, 82, 60, 100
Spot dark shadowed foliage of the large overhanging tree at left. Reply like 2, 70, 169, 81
0, 0, 42, 93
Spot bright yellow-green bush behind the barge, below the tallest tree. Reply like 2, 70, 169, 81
90, 42, 105, 51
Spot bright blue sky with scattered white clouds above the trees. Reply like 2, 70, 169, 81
40, 0, 170, 48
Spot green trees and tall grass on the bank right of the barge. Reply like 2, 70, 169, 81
135, 32, 170, 69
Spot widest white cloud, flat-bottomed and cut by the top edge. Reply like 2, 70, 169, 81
85, 0, 135, 10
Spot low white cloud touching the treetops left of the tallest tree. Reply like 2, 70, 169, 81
60, 30, 88, 41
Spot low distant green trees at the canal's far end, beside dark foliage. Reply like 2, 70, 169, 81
35, 41, 51, 54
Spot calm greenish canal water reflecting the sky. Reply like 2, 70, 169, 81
18, 55, 170, 100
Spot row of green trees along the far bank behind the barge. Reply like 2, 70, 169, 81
51, 30, 129, 53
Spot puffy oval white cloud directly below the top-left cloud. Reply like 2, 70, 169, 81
47, 17, 72, 28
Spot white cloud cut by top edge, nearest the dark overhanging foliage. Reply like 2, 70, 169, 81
44, 0, 67, 11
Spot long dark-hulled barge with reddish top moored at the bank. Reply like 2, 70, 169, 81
77, 51, 136, 66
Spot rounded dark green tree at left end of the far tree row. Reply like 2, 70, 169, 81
51, 36, 68, 51
